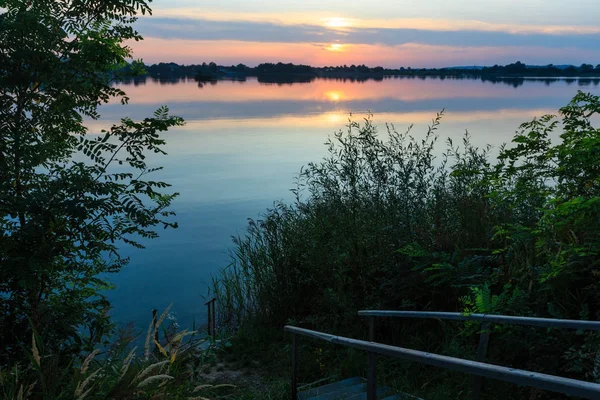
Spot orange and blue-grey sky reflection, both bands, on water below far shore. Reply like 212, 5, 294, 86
97, 78, 598, 125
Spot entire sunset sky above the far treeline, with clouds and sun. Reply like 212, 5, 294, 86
132, 0, 600, 68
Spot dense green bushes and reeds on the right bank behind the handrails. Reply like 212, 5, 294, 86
213, 92, 600, 396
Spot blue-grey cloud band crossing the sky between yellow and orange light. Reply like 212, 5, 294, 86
136, 17, 600, 50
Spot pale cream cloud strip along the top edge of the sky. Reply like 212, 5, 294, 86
153, 0, 598, 29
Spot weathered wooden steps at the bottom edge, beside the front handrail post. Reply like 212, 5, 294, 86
298, 377, 405, 400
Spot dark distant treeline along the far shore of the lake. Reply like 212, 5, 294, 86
121, 61, 600, 85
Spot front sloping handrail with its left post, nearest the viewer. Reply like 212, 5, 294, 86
284, 326, 600, 400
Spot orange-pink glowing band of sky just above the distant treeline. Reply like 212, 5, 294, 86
128, 36, 598, 68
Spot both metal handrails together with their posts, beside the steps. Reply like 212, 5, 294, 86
284, 310, 600, 400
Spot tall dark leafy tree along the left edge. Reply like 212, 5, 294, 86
0, 0, 183, 366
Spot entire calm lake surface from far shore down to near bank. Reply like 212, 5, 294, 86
89, 79, 600, 327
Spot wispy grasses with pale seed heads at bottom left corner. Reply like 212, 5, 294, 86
0, 309, 231, 400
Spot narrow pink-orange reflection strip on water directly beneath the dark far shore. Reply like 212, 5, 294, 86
111, 78, 597, 104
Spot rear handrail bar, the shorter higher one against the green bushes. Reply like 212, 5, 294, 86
358, 310, 600, 331
